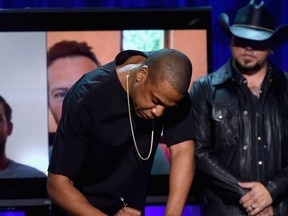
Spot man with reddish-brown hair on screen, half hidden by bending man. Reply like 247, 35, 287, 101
47, 40, 101, 132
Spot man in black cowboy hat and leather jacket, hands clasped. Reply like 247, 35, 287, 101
190, 0, 288, 216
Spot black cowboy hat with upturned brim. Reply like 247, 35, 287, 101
219, 0, 288, 44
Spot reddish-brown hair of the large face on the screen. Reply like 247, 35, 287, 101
47, 40, 101, 67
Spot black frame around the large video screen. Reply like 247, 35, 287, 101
0, 6, 212, 205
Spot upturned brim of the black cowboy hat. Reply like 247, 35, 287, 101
219, 13, 288, 44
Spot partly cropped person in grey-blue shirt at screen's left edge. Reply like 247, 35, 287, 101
0, 95, 47, 179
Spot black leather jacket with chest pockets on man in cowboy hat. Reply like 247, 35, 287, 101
190, 60, 288, 216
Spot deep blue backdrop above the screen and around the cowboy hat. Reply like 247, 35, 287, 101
0, 0, 288, 71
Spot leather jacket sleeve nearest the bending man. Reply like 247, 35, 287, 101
190, 77, 247, 202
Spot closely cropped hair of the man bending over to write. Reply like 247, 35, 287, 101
145, 48, 192, 94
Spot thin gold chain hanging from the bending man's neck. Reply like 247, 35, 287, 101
126, 67, 155, 160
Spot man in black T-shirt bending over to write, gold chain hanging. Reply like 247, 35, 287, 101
47, 49, 194, 216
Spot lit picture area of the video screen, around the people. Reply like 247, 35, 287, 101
0, 29, 207, 177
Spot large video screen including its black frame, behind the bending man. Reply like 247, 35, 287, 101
0, 8, 211, 208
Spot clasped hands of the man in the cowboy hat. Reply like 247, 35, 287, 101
239, 182, 273, 216
